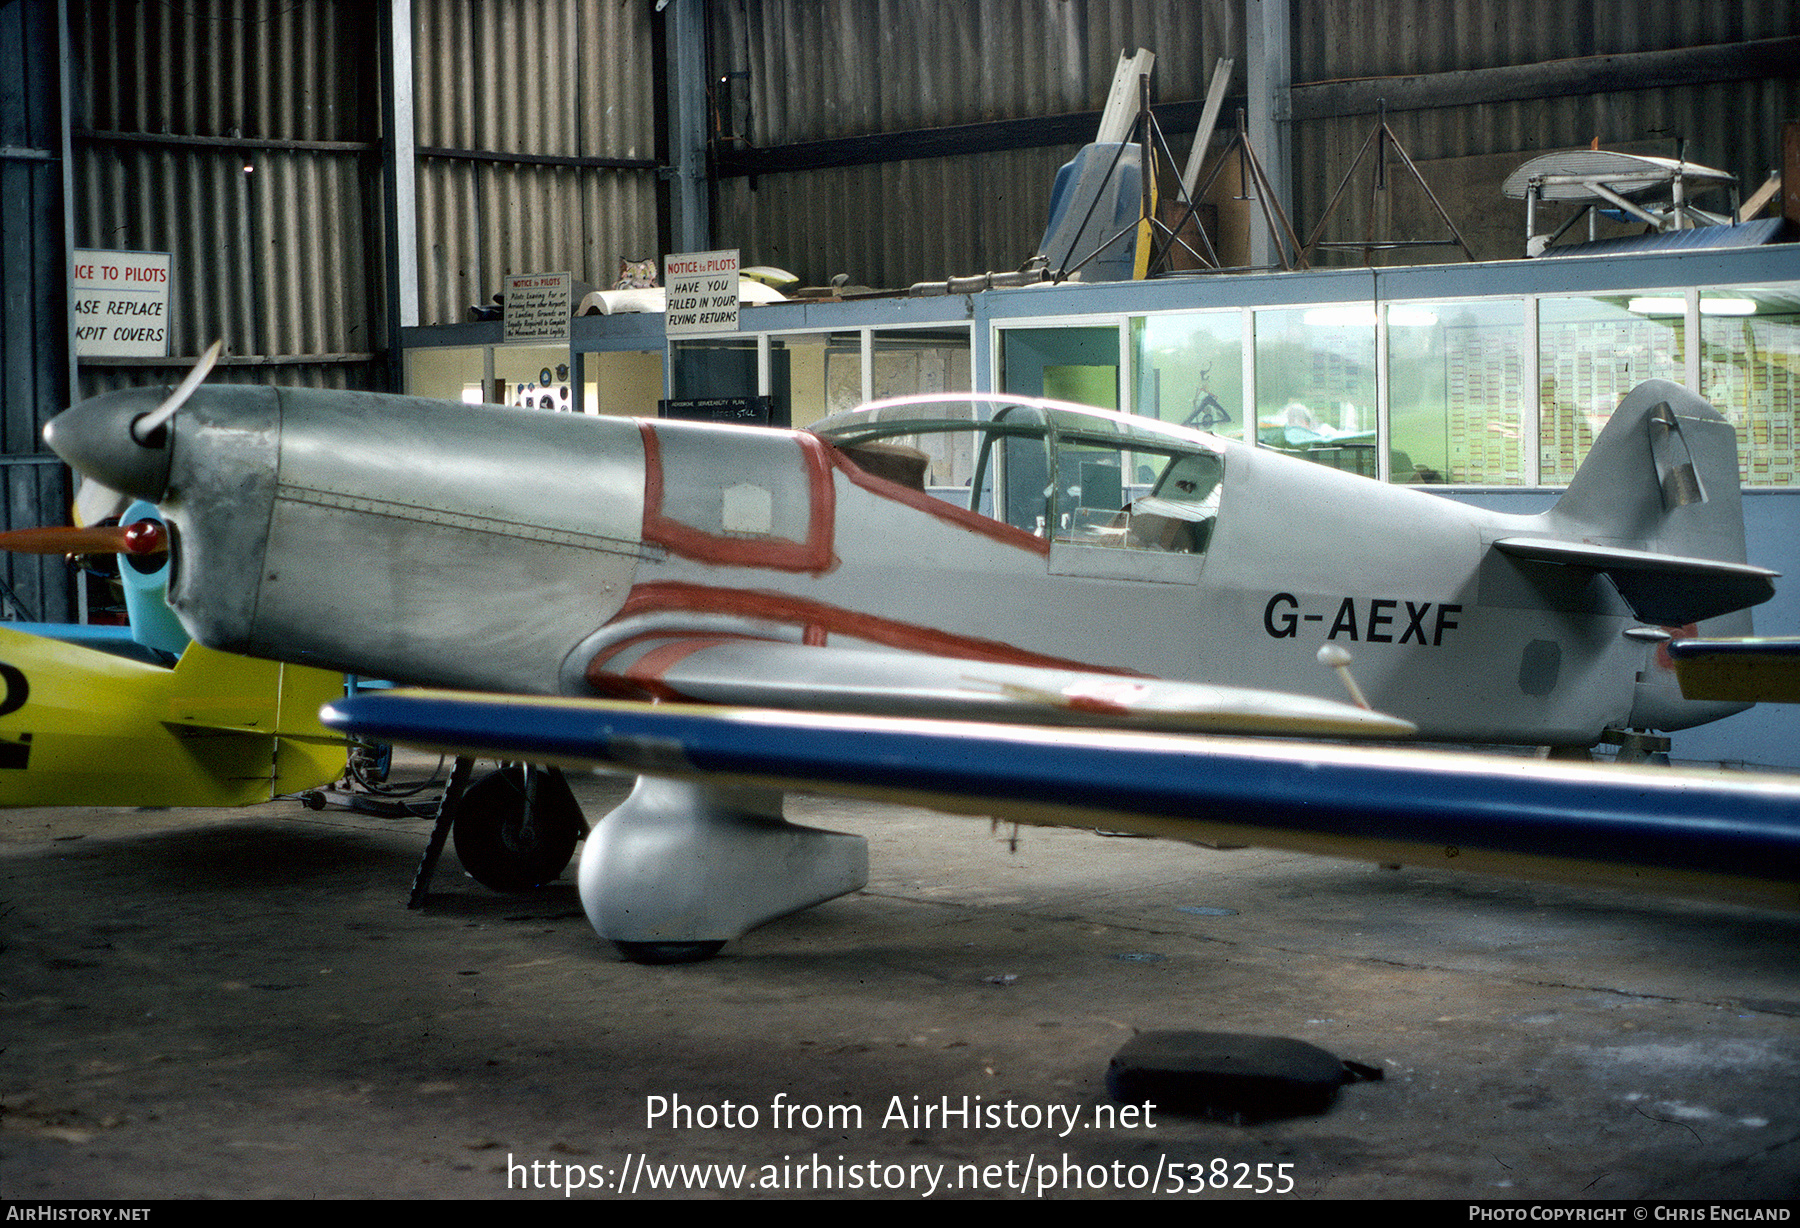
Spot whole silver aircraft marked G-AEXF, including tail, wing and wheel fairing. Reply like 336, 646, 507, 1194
47, 369, 1773, 958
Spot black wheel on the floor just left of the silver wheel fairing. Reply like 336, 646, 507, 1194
452, 765, 587, 891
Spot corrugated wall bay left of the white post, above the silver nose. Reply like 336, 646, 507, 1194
68, 0, 385, 394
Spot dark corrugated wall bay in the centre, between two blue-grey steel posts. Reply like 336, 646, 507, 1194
707, 0, 1244, 286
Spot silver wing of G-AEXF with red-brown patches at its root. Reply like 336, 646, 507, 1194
585, 636, 1415, 738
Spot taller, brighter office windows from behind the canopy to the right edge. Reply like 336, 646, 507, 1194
995, 283, 1800, 488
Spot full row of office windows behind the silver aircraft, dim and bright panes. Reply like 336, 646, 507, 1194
407, 281, 1800, 488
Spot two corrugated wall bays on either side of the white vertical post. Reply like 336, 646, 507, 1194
68, 0, 659, 393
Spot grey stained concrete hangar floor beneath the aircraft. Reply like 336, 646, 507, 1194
0, 763, 1800, 1201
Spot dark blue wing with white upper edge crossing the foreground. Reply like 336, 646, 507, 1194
322, 691, 1800, 907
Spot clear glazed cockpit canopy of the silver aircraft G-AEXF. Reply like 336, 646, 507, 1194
812, 394, 1224, 555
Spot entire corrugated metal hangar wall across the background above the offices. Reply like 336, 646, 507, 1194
10, 0, 1800, 612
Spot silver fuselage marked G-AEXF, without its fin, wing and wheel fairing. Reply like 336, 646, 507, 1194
58, 385, 1748, 745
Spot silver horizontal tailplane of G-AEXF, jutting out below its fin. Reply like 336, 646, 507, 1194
1494, 537, 1780, 627
